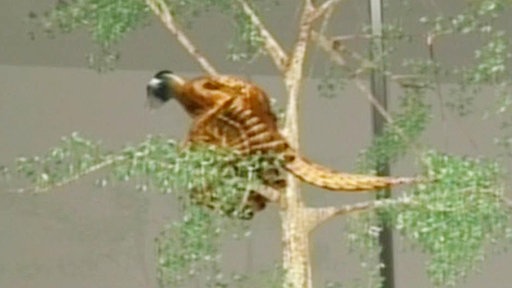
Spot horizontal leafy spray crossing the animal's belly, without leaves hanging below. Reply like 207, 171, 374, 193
7, 134, 281, 218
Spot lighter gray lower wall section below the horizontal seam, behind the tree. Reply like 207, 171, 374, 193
0, 66, 512, 288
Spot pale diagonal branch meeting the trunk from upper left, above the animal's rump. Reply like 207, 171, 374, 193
238, 0, 288, 72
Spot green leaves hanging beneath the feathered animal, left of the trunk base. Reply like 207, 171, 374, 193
156, 195, 284, 288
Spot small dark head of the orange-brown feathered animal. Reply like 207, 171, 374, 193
147, 70, 185, 109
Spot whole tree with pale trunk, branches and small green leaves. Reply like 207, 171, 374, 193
4, 0, 512, 287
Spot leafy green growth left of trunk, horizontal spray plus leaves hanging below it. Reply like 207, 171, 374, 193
2, 133, 281, 287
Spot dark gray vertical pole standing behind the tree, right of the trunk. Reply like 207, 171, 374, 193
369, 0, 395, 288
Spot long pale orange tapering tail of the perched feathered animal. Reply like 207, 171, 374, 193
285, 153, 420, 192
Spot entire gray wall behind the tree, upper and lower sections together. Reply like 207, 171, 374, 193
0, 0, 512, 288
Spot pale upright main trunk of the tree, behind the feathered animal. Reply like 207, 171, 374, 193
281, 0, 315, 288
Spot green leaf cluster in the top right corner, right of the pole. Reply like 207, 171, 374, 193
420, 0, 512, 115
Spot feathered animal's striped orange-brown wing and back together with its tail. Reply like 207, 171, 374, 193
183, 76, 417, 191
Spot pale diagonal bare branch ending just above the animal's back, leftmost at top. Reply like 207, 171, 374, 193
145, 0, 218, 75
